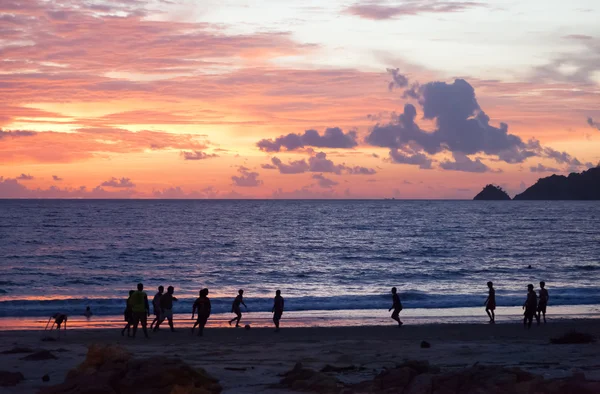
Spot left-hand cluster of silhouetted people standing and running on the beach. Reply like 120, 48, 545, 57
121, 283, 284, 338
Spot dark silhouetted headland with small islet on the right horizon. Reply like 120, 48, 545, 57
473, 166, 600, 200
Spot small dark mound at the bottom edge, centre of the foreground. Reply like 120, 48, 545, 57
279, 363, 344, 393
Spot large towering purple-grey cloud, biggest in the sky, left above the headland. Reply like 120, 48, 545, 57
365, 79, 581, 172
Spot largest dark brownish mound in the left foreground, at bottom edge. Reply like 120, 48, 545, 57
40, 345, 222, 394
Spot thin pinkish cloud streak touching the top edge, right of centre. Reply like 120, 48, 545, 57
346, 0, 485, 20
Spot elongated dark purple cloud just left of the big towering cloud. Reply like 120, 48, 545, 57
256, 127, 358, 152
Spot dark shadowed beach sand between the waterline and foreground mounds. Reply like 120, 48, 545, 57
0, 319, 600, 394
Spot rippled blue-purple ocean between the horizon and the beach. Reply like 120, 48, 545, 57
0, 200, 600, 324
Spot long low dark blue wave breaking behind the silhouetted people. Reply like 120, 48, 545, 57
0, 288, 600, 317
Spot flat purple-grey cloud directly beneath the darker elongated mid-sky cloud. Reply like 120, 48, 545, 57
261, 152, 376, 175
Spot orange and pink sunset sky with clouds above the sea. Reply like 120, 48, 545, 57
0, 0, 600, 199
